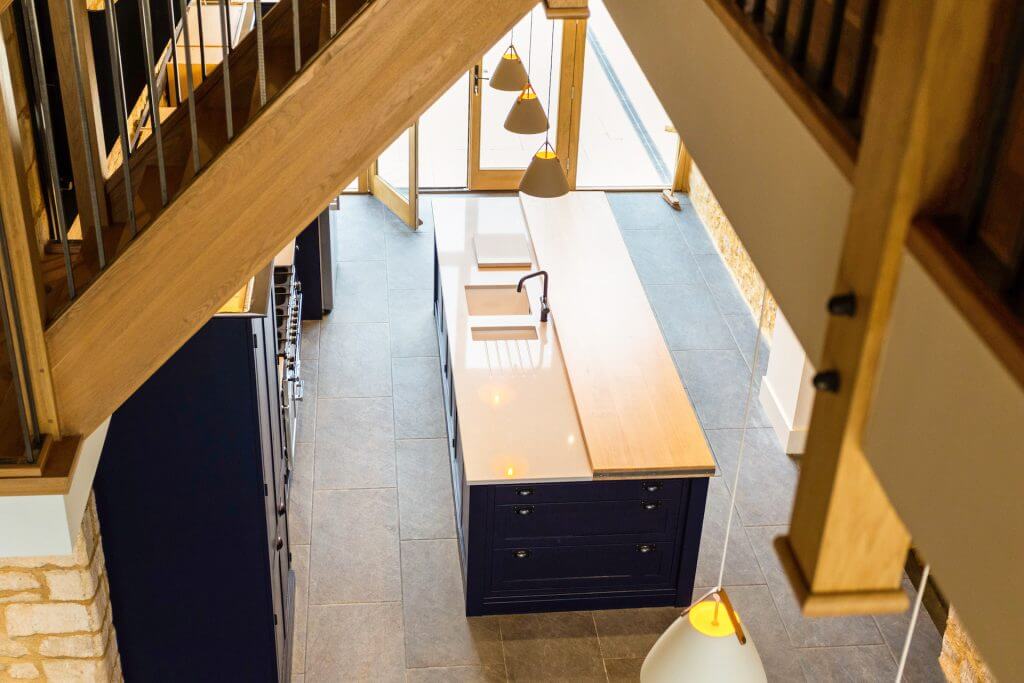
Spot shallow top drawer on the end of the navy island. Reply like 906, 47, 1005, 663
495, 479, 688, 504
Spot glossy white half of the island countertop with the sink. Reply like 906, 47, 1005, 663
432, 197, 593, 484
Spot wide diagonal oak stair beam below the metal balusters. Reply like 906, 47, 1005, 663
46, 0, 534, 434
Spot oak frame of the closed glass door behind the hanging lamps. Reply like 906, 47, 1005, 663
466, 18, 587, 190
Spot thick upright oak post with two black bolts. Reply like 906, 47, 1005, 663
787, 0, 997, 614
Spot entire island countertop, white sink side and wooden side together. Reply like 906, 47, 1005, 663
433, 193, 715, 484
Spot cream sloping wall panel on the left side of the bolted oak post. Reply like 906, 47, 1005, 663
605, 0, 852, 365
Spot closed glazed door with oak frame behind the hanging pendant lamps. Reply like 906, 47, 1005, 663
468, 10, 587, 190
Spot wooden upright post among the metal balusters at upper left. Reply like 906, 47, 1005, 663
45, 0, 111, 263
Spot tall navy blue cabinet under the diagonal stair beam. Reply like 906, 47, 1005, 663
95, 270, 294, 683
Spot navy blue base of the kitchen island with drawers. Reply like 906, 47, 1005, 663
434, 242, 708, 615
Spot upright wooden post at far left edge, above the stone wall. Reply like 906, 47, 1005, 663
0, 24, 60, 436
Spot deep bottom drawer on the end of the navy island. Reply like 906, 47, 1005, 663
490, 542, 675, 591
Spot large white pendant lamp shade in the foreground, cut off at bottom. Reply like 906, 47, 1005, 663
640, 591, 768, 683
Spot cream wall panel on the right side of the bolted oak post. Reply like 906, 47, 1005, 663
863, 254, 1024, 680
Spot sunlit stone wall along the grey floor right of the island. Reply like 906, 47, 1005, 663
690, 164, 777, 339
